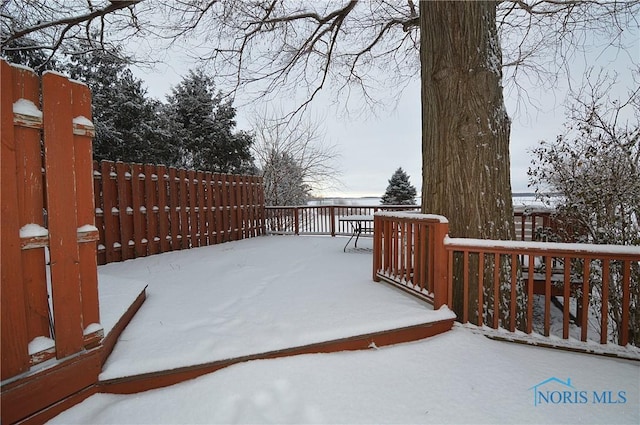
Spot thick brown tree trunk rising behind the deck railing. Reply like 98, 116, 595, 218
420, 1, 514, 239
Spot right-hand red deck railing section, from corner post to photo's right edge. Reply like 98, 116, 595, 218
444, 238, 640, 346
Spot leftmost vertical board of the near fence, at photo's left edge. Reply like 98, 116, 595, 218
0, 61, 29, 380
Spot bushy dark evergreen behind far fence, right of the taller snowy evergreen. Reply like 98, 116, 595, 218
167, 70, 253, 173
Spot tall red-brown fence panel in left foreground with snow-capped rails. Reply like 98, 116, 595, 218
0, 61, 102, 378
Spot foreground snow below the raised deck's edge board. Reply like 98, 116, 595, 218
51, 327, 640, 424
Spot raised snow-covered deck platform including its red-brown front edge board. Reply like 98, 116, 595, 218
99, 236, 454, 393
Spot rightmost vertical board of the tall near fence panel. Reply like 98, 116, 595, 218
71, 79, 100, 328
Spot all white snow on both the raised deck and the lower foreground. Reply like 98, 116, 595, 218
51, 236, 640, 424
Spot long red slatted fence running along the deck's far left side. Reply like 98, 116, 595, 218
93, 161, 265, 264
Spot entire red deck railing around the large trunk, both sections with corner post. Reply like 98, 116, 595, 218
374, 212, 640, 346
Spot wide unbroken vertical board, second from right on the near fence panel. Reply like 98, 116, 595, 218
42, 72, 83, 358
